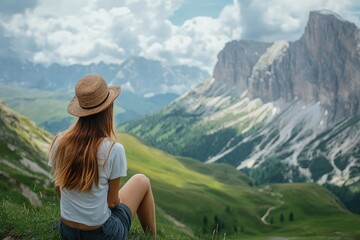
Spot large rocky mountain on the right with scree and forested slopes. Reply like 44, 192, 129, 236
121, 11, 360, 191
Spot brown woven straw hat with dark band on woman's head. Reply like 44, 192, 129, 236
67, 75, 121, 117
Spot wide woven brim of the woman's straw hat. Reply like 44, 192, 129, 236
67, 86, 121, 117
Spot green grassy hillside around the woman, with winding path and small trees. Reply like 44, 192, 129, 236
0, 102, 360, 239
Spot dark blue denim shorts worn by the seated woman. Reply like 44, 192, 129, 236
60, 203, 132, 240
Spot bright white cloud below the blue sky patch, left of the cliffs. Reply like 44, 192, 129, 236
142, 2, 241, 72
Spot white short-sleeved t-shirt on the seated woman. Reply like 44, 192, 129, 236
48, 137, 127, 226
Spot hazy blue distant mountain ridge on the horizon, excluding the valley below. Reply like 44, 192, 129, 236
0, 57, 209, 97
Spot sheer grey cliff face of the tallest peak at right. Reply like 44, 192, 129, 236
249, 11, 360, 123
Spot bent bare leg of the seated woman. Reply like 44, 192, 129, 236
119, 174, 156, 236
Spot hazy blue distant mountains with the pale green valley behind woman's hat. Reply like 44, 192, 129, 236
0, 57, 209, 133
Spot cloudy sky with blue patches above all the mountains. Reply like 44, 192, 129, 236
0, 0, 360, 73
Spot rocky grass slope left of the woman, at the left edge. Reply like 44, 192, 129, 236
0, 103, 53, 206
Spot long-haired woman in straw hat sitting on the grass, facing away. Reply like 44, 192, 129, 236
49, 75, 156, 239
